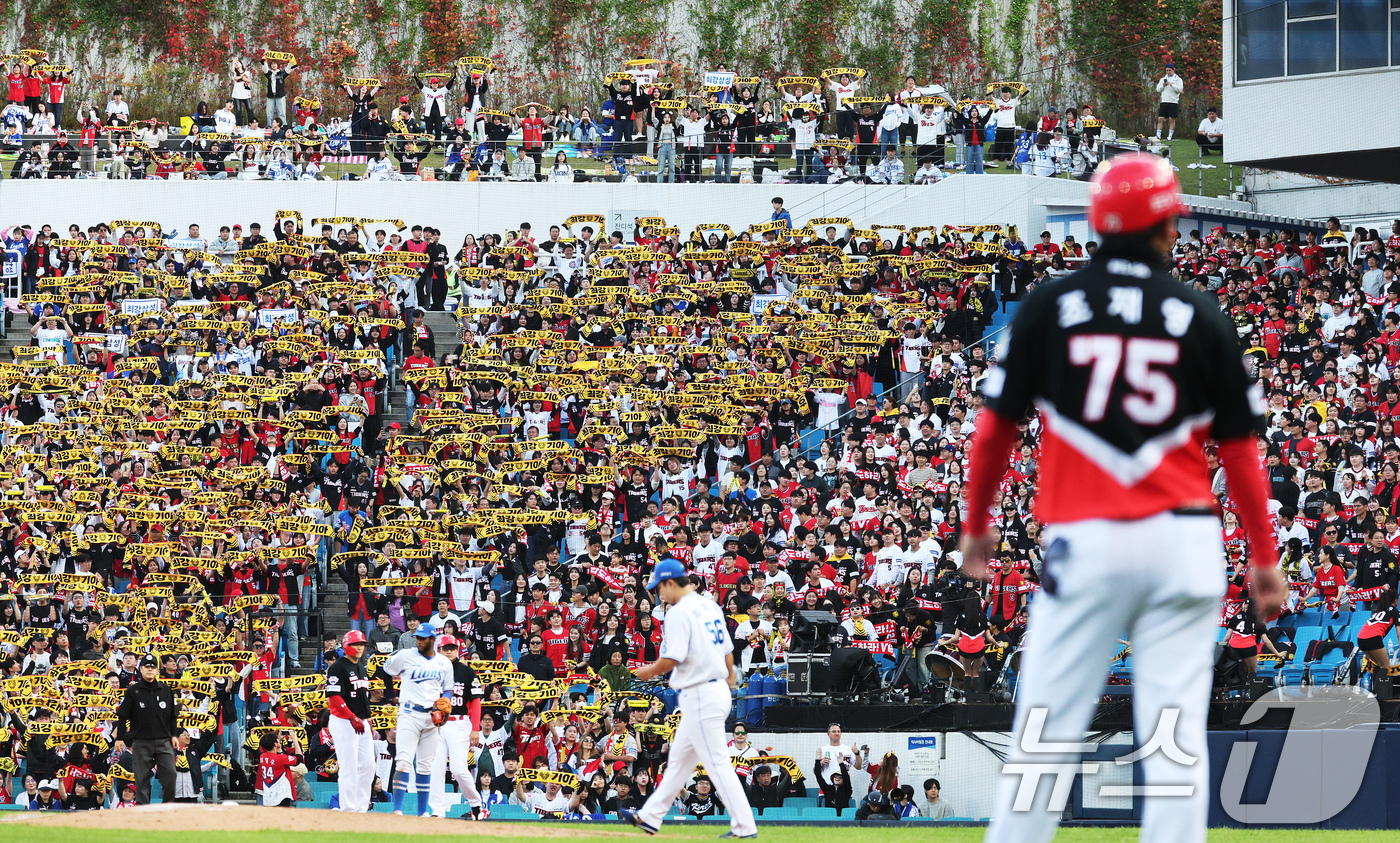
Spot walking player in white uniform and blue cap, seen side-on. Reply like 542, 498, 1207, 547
617, 559, 759, 837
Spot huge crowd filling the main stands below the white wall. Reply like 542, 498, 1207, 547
0, 199, 1400, 814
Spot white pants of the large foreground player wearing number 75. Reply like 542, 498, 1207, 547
986, 513, 1225, 843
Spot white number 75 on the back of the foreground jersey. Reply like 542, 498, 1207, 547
1070, 333, 1182, 424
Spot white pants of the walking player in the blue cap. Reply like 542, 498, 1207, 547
638, 681, 759, 836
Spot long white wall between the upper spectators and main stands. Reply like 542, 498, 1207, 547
0, 174, 1271, 251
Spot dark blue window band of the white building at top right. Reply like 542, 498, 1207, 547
1235, 0, 1400, 81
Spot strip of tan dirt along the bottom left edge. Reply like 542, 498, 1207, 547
0, 804, 627, 839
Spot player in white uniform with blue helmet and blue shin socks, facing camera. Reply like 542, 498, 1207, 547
384, 623, 452, 816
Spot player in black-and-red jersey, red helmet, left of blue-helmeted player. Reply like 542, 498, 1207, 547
326, 629, 375, 814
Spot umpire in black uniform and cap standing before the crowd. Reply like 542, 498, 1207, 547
116, 655, 179, 805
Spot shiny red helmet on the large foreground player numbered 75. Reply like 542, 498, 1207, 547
1089, 153, 1189, 234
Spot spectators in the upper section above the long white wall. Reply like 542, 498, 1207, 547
0, 53, 1112, 185
